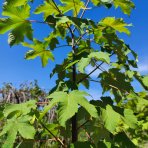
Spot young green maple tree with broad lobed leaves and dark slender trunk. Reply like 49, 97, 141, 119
0, 0, 148, 148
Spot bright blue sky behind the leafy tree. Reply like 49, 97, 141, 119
0, 0, 148, 96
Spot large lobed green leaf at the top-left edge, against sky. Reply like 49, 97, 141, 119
0, 5, 33, 46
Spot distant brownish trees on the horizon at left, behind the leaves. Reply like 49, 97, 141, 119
0, 80, 56, 122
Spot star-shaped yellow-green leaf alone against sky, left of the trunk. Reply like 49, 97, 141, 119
23, 39, 54, 67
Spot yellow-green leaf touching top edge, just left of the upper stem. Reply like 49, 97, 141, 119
34, 0, 61, 20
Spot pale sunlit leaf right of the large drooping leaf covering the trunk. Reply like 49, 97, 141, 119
102, 105, 121, 133
